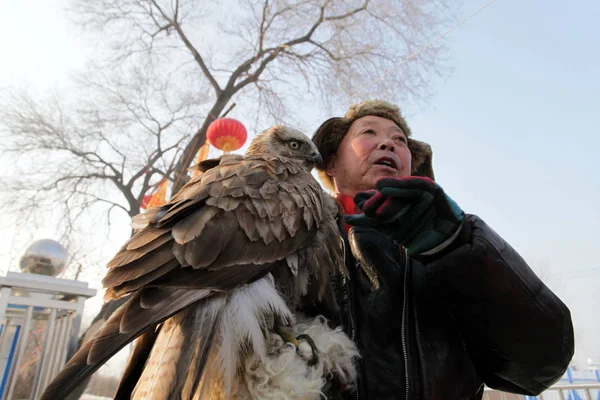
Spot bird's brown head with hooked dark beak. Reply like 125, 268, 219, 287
246, 125, 323, 169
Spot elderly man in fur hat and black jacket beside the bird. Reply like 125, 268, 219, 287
313, 101, 573, 400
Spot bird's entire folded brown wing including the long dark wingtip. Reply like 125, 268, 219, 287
43, 156, 332, 399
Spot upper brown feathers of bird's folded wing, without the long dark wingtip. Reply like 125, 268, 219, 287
103, 153, 324, 298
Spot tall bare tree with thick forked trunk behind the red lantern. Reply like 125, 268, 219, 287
69, 0, 449, 190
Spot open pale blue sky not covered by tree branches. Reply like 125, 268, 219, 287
0, 0, 600, 366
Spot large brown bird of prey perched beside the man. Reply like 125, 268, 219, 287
42, 125, 352, 400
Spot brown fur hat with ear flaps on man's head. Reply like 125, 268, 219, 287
312, 100, 434, 191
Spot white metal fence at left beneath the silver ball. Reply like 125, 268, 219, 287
0, 272, 96, 400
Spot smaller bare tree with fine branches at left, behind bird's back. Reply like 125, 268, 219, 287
0, 62, 202, 237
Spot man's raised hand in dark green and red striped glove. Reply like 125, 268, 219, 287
345, 177, 464, 255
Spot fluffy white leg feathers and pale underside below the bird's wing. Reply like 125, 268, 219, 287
189, 276, 358, 400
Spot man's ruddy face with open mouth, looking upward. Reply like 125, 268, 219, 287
327, 115, 411, 196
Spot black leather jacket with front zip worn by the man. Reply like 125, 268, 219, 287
320, 215, 574, 400
